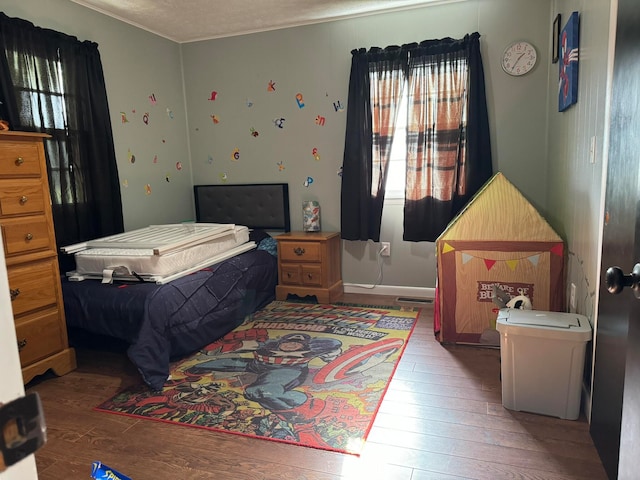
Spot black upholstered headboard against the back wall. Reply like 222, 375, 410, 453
193, 183, 291, 232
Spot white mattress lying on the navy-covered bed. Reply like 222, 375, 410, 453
68, 224, 250, 281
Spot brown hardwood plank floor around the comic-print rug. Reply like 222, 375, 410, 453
27, 294, 606, 480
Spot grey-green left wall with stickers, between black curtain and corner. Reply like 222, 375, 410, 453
0, 0, 193, 230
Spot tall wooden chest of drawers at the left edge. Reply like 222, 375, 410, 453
0, 132, 76, 383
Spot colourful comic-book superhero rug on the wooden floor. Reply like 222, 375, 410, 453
96, 301, 419, 455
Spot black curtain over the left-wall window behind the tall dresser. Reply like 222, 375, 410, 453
0, 13, 124, 271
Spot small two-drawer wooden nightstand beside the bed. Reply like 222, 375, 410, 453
275, 232, 343, 303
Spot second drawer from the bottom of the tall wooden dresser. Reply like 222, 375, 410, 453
7, 258, 59, 317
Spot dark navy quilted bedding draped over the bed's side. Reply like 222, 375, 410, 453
62, 248, 278, 390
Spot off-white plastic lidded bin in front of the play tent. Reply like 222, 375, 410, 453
496, 308, 591, 420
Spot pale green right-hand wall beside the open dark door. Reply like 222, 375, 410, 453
547, 0, 617, 418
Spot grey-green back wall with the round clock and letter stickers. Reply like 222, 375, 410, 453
182, 0, 550, 291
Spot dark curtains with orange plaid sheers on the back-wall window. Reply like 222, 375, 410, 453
341, 33, 493, 241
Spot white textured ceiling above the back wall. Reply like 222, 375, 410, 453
71, 0, 461, 43
